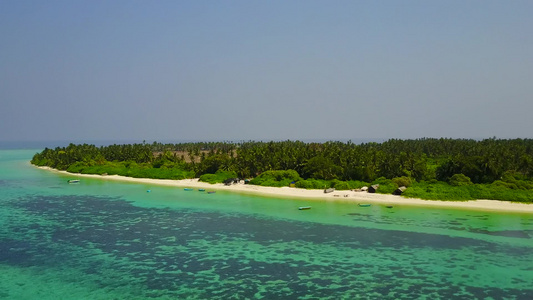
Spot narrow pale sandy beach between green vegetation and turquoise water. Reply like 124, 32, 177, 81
39, 167, 533, 213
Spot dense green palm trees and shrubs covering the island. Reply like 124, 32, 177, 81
32, 138, 533, 201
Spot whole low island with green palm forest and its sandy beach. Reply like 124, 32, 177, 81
31, 138, 533, 207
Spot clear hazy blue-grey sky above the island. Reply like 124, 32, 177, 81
0, 0, 533, 142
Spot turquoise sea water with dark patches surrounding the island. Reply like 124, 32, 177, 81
0, 150, 533, 299
